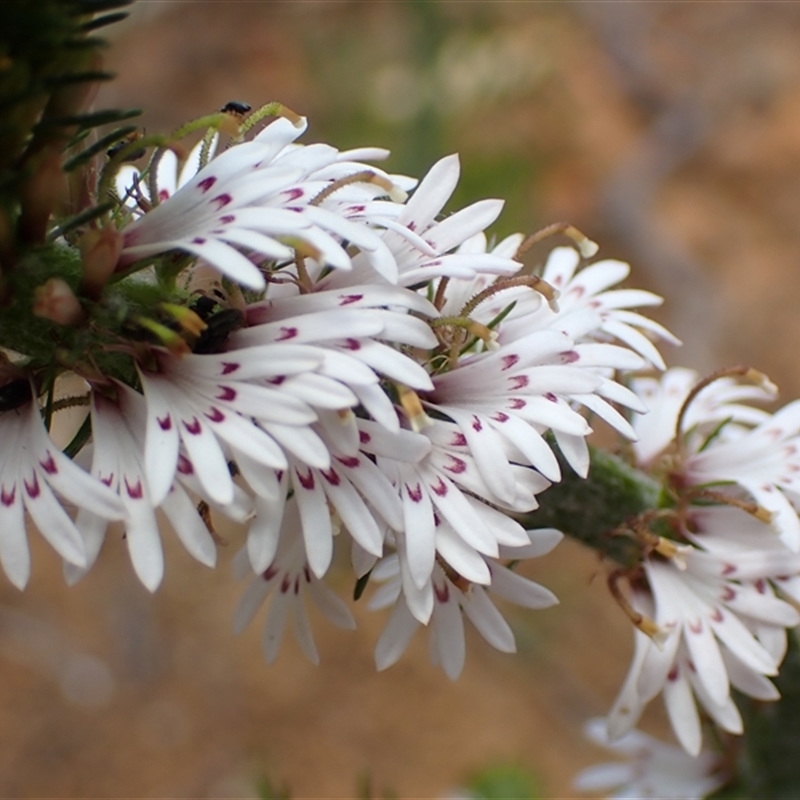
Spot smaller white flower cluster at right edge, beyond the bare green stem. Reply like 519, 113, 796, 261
608, 369, 800, 755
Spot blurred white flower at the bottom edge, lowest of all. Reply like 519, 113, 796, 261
572, 719, 727, 800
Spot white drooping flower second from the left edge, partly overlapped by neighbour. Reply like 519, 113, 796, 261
67, 384, 234, 591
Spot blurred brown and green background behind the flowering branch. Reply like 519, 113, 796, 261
0, 0, 800, 798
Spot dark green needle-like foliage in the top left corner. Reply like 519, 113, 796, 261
0, 0, 139, 250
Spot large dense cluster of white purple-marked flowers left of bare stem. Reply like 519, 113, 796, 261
0, 100, 672, 678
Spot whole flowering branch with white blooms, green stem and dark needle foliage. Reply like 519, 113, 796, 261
0, 0, 800, 796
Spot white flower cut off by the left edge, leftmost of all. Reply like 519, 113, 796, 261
0, 401, 125, 589
